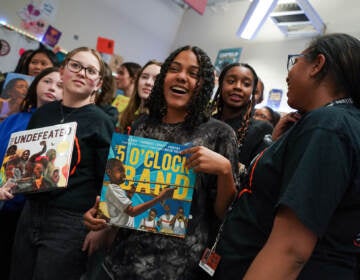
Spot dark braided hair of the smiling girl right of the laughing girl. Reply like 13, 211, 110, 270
212, 62, 258, 147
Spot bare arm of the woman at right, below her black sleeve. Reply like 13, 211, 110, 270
244, 207, 317, 280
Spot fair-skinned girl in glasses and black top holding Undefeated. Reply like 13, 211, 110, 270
10, 47, 114, 279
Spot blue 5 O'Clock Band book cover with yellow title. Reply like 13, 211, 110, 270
99, 133, 196, 238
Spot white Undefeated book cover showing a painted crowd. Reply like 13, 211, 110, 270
0, 122, 77, 194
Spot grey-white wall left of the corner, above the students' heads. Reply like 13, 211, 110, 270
0, 0, 183, 64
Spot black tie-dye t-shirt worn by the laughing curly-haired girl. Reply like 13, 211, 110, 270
105, 117, 238, 279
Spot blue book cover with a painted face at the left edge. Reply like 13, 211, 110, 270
0, 73, 34, 120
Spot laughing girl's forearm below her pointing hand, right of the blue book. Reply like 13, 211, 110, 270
215, 161, 236, 219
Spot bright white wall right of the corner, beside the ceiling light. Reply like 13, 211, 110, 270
174, 1, 310, 112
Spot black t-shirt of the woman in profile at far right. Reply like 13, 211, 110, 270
217, 104, 360, 279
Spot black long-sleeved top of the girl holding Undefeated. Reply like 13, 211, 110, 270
28, 101, 115, 212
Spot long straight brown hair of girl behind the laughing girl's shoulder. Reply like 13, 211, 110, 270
119, 60, 162, 133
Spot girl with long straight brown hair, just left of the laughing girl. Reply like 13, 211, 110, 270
117, 60, 161, 133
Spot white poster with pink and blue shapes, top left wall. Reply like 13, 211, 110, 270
17, 0, 58, 37
